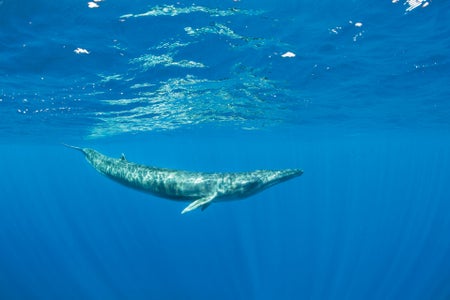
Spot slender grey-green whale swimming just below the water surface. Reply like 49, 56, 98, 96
64, 144, 303, 214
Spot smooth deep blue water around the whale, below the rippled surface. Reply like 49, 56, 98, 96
0, 131, 450, 299
